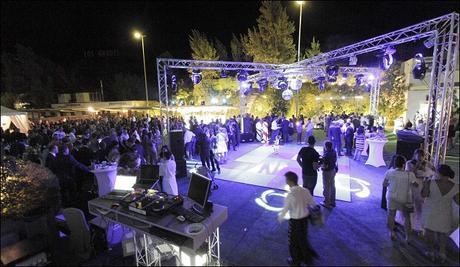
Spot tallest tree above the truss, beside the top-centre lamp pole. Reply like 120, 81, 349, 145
242, 1, 296, 64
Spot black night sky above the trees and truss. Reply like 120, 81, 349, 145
1, 1, 460, 90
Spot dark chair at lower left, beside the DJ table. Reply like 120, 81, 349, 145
63, 208, 92, 260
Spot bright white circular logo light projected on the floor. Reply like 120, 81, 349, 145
255, 177, 371, 212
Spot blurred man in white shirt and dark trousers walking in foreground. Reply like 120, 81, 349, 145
278, 172, 318, 266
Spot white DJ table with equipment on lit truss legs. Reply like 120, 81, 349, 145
88, 197, 228, 266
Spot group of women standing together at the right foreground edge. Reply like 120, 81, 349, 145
383, 152, 459, 263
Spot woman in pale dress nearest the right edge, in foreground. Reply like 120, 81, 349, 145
422, 165, 459, 263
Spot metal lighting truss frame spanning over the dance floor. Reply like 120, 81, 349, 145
157, 13, 460, 165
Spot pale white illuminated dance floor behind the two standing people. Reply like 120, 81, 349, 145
196, 144, 351, 202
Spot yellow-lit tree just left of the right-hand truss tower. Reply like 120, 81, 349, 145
379, 62, 409, 125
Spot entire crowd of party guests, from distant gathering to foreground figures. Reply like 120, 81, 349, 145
0, 113, 458, 264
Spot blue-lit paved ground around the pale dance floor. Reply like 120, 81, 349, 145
72, 131, 459, 266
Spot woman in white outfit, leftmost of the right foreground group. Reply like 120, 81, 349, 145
383, 155, 417, 242
